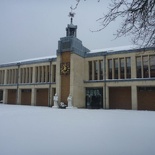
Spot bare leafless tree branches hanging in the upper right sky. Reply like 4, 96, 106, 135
71, 0, 155, 47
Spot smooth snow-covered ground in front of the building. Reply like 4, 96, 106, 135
0, 104, 155, 155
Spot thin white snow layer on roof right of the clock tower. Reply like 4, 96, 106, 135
90, 45, 139, 53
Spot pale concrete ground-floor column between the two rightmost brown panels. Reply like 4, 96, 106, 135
131, 86, 138, 110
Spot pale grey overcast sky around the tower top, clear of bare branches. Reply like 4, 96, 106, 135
0, 0, 131, 64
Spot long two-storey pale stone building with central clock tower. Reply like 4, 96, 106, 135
0, 18, 155, 110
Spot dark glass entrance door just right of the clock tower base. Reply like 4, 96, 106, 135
86, 88, 103, 109
